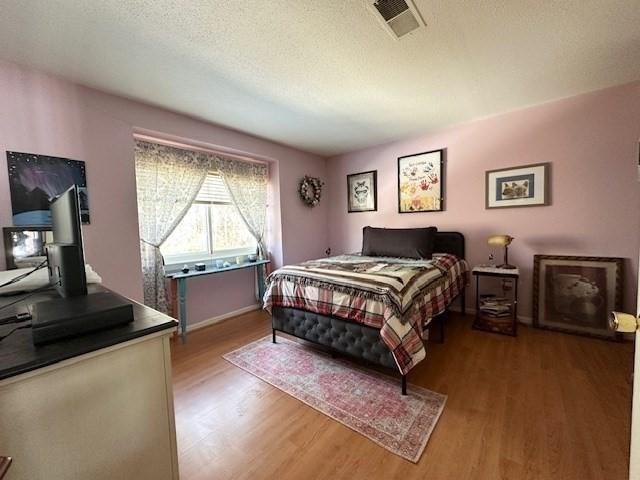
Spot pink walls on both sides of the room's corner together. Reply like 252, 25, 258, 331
0, 57, 640, 322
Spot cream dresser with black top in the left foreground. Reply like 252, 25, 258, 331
0, 288, 178, 480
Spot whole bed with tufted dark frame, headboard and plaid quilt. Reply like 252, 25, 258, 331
264, 232, 469, 395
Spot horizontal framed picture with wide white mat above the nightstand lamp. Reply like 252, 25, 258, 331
485, 163, 550, 208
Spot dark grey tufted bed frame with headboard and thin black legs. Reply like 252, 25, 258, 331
271, 232, 465, 395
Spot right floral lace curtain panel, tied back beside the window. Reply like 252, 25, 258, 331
213, 156, 269, 258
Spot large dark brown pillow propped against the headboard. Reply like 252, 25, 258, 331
362, 227, 438, 260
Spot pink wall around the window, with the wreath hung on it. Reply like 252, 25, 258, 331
0, 62, 328, 322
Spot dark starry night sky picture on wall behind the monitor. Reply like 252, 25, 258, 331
7, 151, 89, 226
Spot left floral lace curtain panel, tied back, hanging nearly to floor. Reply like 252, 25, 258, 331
135, 140, 211, 313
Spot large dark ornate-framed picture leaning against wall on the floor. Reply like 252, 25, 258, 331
533, 255, 624, 339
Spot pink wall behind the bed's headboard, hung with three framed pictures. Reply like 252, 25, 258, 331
328, 82, 640, 317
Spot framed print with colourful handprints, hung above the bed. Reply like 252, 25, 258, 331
398, 150, 444, 213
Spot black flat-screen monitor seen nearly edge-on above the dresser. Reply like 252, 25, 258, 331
46, 185, 87, 298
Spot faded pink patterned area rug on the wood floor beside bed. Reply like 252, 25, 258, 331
223, 336, 447, 463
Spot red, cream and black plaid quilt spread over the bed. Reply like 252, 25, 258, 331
264, 254, 468, 374
